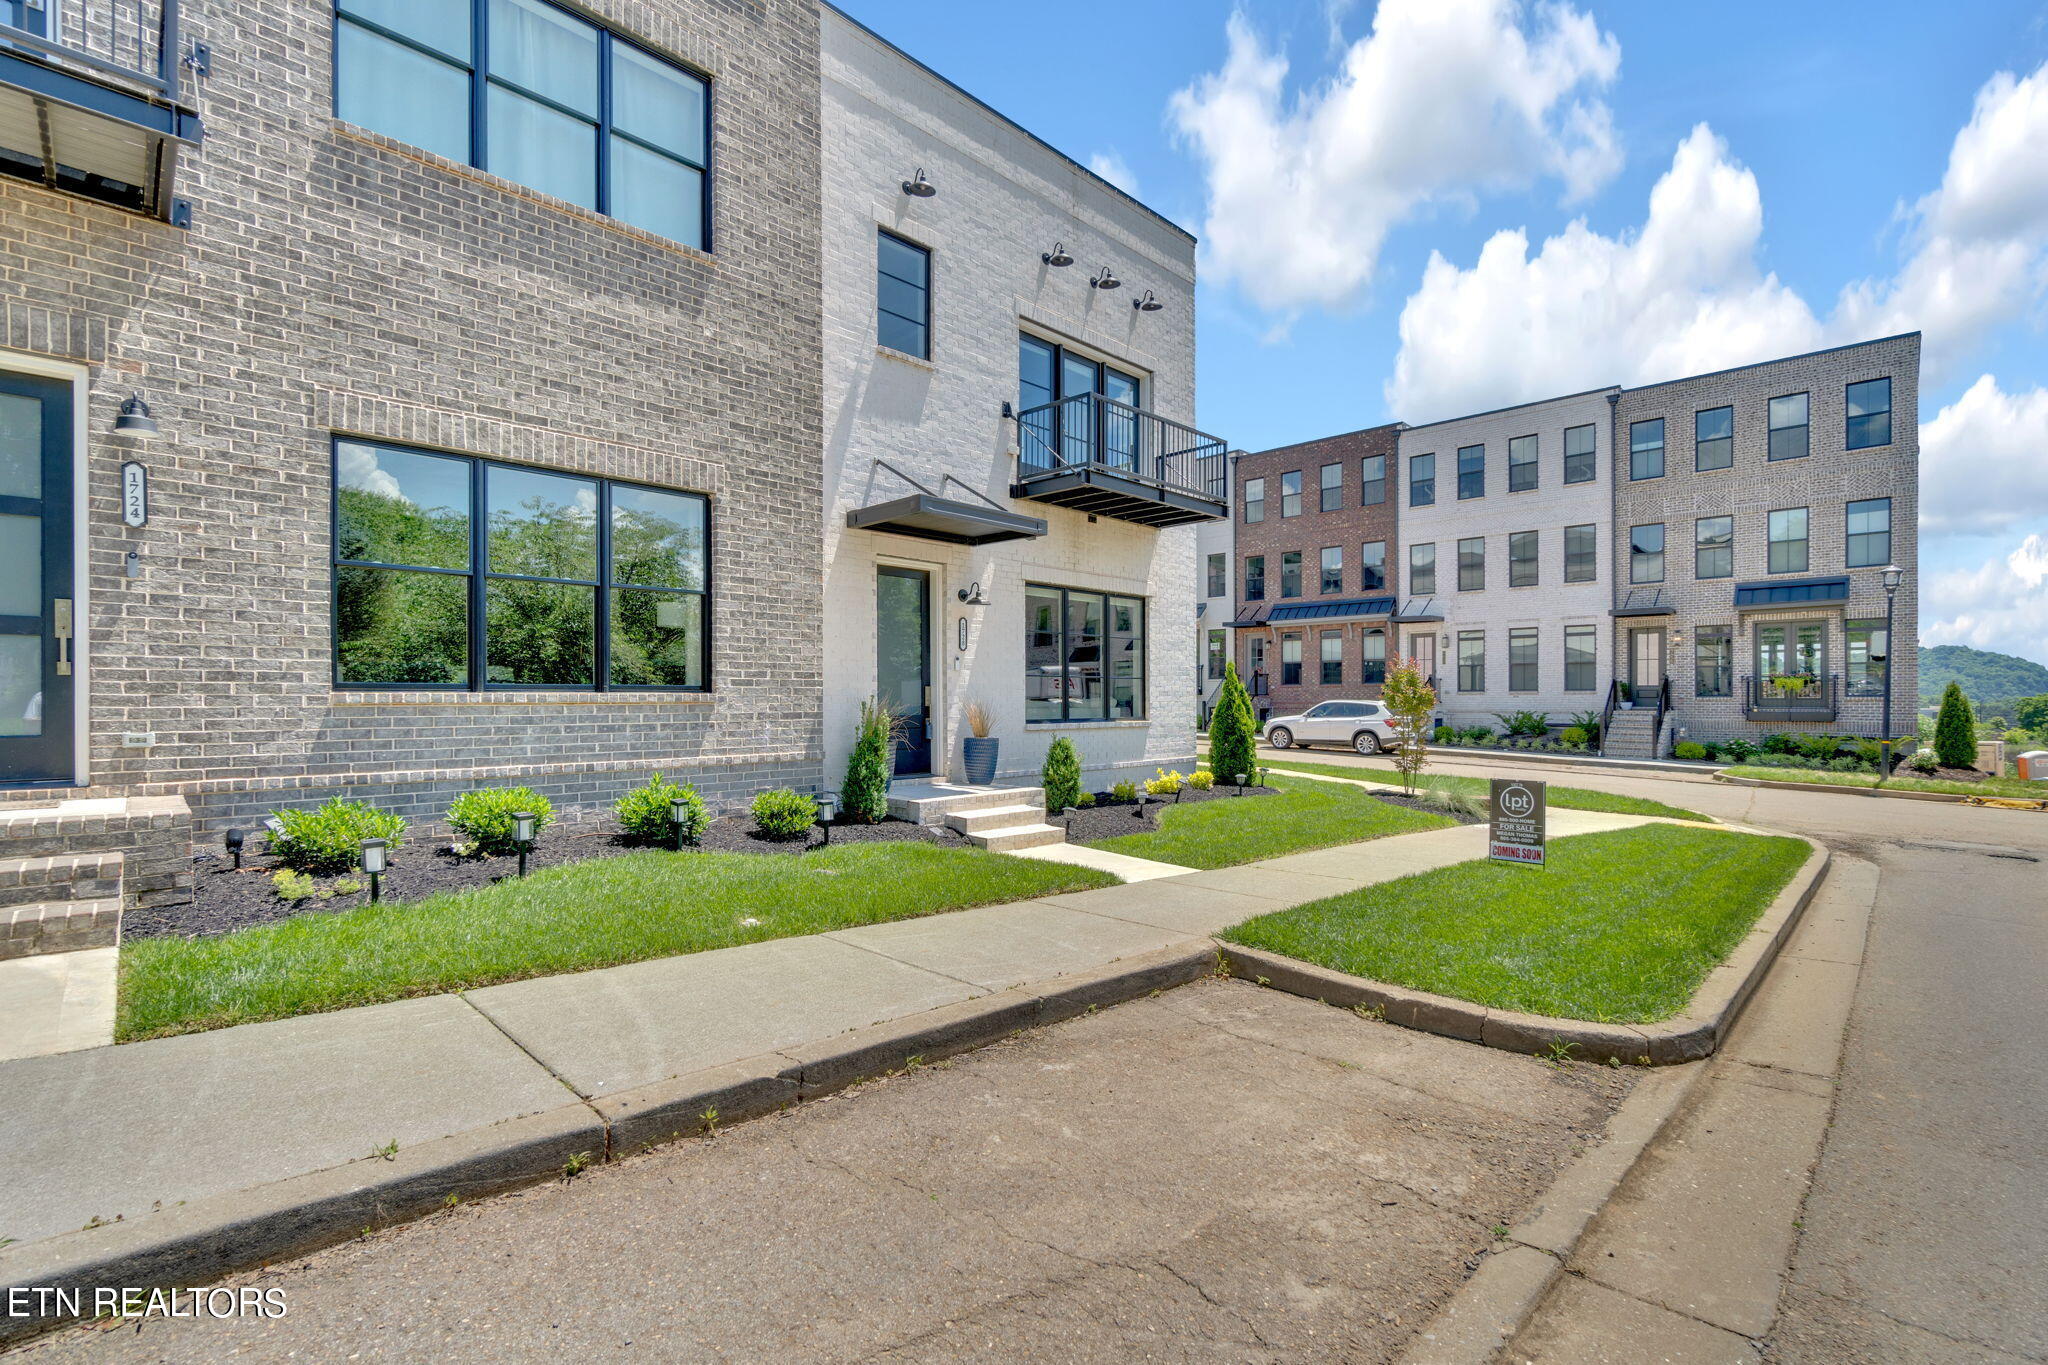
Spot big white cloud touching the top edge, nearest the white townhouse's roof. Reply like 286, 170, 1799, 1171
1169, 0, 1622, 313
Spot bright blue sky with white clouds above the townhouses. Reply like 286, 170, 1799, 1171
838, 0, 2048, 661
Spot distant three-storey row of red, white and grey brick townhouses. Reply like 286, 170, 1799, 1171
1198, 334, 1919, 751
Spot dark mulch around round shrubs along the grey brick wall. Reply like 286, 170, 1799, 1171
136, 814, 950, 939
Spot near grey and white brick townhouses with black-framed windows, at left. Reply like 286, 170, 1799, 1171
0, 0, 1229, 916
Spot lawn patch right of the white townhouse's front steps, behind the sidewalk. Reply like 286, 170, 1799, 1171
1094, 780, 1454, 868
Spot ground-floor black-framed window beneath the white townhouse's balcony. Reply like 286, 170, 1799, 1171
1024, 583, 1145, 722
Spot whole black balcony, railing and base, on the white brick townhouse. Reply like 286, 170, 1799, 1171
1010, 393, 1229, 526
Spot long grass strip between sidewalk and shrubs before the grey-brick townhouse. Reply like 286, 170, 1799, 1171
115, 843, 1116, 1042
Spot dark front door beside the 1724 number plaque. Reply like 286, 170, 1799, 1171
0, 370, 76, 786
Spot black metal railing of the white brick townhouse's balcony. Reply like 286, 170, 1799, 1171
1016, 393, 1229, 501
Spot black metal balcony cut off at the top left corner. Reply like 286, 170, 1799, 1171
0, 0, 207, 221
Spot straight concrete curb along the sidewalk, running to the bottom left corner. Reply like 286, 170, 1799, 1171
0, 939, 1217, 1342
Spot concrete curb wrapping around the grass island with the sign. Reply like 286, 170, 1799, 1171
1221, 835, 1831, 1066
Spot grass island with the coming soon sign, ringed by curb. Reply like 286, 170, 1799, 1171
1219, 825, 1810, 1023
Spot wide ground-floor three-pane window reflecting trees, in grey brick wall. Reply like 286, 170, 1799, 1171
334, 438, 711, 692
